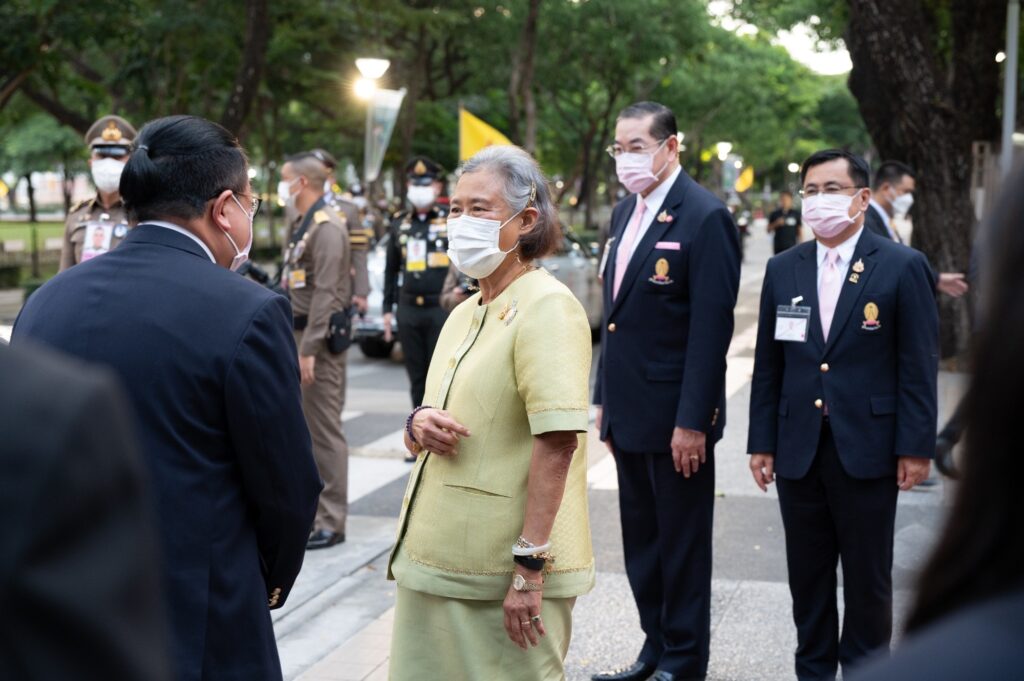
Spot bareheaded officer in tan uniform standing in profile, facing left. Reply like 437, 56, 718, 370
279, 154, 352, 549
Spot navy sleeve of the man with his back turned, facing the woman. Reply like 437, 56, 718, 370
225, 296, 323, 606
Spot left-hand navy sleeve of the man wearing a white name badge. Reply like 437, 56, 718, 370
746, 260, 785, 454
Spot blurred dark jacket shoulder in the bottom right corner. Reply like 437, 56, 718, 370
850, 590, 1024, 681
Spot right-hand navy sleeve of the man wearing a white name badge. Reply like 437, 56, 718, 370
894, 253, 939, 459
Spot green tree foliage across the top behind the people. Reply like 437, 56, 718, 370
0, 0, 863, 214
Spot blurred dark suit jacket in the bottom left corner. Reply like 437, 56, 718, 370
0, 343, 170, 681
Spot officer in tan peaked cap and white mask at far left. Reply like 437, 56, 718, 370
60, 116, 137, 271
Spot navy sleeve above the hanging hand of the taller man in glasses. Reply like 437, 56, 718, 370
676, 208, 740, 432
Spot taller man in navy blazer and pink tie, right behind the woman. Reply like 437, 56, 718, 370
593, 102, 740, 681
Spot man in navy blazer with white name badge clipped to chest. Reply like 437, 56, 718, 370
748, 150, 938, 681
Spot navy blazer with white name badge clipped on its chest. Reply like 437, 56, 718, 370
748, 229, 939, 479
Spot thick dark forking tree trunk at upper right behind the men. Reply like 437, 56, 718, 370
846, 0, 1006, 356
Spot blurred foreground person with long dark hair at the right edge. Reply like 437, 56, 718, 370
851, 160, 1024, 681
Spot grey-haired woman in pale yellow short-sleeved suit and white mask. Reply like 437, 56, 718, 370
388, 145, 594, 681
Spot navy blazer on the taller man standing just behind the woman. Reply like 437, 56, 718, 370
594, 172, 740, 453
